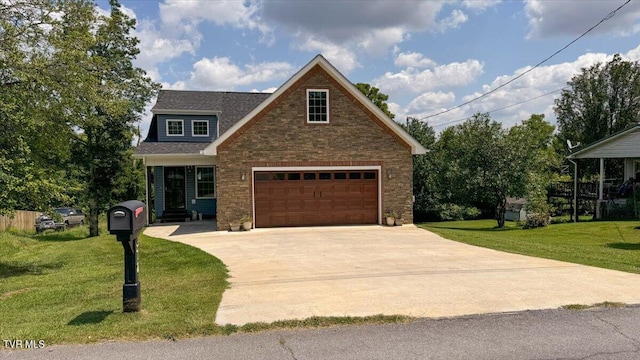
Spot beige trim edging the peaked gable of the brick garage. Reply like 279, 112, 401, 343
203, 55, 427, 155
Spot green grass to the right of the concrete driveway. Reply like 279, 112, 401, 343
418, 220, 640, 274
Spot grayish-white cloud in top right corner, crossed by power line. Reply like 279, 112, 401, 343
525, 0, 640, 38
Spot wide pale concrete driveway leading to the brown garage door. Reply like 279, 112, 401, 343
145, 223, 640, 325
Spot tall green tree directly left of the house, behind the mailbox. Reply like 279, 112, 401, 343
50, 0, 158, 236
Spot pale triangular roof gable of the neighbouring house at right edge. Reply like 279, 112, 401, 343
567, 124, 640, 159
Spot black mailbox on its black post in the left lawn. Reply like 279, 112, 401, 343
107, 200, 147, 312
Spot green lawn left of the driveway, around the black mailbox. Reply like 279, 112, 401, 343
0, 226, 227, 345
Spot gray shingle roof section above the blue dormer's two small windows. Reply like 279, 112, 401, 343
151, 90, 271, 134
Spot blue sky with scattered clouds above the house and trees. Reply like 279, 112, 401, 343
98, 0, 640, 138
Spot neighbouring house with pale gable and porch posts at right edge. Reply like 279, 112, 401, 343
567, 124, 640, 219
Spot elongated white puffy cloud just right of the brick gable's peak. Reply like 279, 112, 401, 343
373, 59, 483, 94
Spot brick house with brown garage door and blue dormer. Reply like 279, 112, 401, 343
135, 55, 427, 230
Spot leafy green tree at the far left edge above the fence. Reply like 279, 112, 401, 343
0, 0, 73, 214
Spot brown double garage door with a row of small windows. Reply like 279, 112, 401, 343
254, 170, 379, 227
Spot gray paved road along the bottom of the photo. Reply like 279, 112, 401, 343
5, 307, 640, 360
